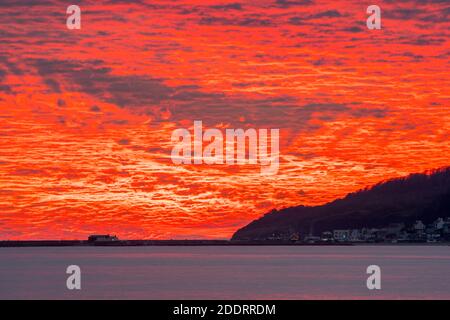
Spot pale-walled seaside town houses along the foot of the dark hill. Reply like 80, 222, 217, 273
276, 218, 450, 244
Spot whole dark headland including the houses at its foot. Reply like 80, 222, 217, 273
232, 167, 450, 243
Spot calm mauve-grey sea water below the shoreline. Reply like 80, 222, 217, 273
0, 246, 450, 299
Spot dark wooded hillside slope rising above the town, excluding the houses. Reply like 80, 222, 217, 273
232, 167, 450, 240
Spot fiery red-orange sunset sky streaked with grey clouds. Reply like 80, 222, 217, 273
0, 0, 450, 239
